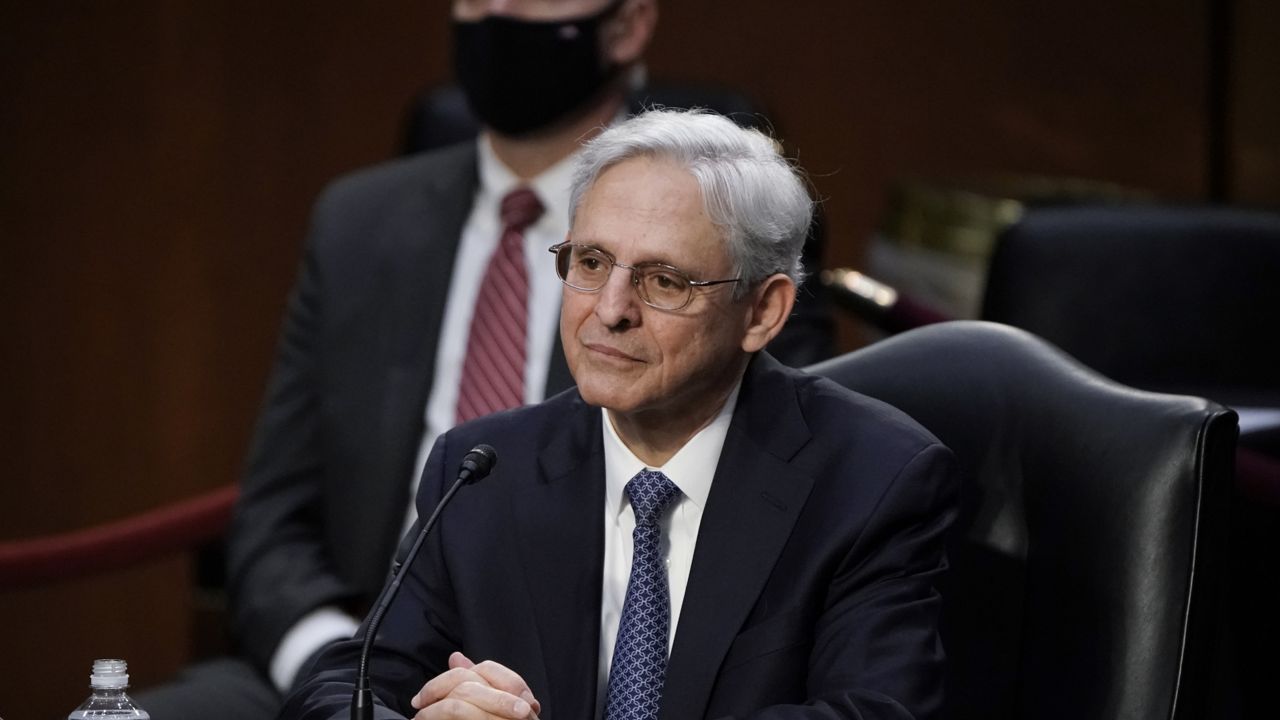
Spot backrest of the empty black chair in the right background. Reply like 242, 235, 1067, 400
982, 205, 1280, 406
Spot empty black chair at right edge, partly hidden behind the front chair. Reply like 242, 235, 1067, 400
983, 205, 1280, 717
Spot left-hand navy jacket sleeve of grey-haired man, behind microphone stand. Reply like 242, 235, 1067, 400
279, 434, 462, 720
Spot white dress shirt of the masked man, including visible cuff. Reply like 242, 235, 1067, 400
270, 133, 573, 692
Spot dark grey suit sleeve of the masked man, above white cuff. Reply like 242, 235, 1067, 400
228, 189, 352, 670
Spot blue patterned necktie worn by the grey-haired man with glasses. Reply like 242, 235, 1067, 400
604, 470, 680, 720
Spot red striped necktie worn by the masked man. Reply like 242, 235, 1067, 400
457, 187, 543, 423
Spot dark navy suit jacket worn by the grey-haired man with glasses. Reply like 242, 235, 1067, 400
283, 354, 956, 720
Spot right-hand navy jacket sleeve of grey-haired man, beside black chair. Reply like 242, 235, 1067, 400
736, 445, 957, 720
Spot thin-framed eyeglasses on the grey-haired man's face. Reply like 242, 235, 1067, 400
548, 242, 741, 310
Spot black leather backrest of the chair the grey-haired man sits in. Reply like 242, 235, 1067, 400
810, 322, 1236, 720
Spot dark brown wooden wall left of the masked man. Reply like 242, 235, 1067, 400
0, 0, 444, 717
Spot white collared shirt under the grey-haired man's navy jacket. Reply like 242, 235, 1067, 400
595, 380, 741, 717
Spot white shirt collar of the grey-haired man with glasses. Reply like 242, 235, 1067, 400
600, 378, 742, 518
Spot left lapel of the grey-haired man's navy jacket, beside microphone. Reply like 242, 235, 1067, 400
509, 398, 604, 717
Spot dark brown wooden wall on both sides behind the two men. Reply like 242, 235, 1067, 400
0, 0, 1280, 717
